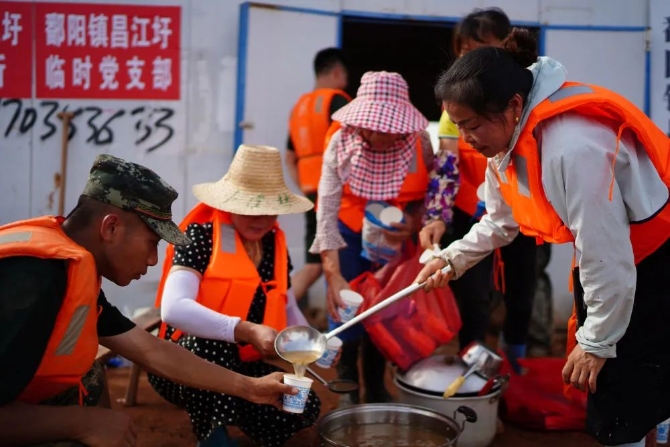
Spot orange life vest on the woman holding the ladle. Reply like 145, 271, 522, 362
496, 82, 670, 400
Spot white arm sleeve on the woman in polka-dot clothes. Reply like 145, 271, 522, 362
161, 270, 243, 343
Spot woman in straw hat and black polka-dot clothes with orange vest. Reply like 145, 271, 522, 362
149, 145, 321, 447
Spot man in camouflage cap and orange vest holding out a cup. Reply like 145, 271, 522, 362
0, 155, 297, 447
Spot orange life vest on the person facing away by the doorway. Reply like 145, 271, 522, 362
289, 88, 351, 193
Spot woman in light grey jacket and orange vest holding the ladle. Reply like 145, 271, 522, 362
417, 28, 670, 447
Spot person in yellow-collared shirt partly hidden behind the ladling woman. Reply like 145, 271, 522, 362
420, 8, 537, 372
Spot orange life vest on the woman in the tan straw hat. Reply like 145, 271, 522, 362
156, 203, 288, 362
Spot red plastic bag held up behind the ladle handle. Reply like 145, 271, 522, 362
350, 244, 461, 370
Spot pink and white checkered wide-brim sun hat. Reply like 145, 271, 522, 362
332, 71, 428, 134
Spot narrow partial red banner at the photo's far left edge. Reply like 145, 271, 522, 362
0, 1, 33, 98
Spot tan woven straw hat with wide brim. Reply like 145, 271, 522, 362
193, 144, 314, 216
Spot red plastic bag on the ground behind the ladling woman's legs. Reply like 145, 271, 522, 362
500, 357, 586, 431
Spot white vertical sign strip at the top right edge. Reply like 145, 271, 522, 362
649, 0, 670, 136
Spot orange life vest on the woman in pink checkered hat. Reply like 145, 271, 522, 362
338, 137, 429, 233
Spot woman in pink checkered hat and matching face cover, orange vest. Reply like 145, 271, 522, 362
310, 71, 440, 405
